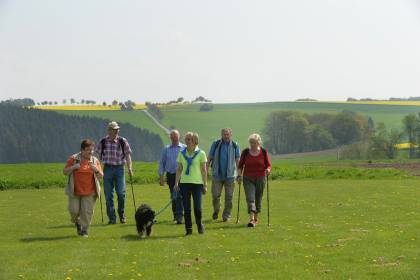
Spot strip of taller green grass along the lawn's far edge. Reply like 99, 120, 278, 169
0, 159, 411, 190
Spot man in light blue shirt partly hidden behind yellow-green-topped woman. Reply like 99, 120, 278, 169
159, 129, 185, 224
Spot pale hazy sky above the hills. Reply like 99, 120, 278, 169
0, 0, 420, 103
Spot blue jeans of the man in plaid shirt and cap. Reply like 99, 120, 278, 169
104, 165, 125, 222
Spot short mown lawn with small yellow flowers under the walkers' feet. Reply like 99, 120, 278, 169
0, 180, 420, 280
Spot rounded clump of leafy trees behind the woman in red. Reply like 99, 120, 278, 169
263, 111, 370, 154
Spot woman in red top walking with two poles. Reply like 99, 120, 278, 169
238, 133, 271, 227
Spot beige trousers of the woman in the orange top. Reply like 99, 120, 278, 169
68, 193, 97, 230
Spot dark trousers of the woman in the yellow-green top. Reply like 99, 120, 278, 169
179, 183, 203, 229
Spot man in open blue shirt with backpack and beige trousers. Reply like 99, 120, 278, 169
207, 128, 240, 222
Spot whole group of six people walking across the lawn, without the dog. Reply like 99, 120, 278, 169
63, 121, 271, 237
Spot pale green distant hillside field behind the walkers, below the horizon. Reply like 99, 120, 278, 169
54, 102, 420, 151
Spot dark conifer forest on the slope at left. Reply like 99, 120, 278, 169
0, 104, 163, 163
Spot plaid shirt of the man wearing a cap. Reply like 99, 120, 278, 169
96, 136, 131, 165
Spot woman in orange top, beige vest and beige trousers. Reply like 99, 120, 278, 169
63, 139, 104, 237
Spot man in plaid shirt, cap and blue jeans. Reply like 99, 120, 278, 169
96, 121, 133, 224
